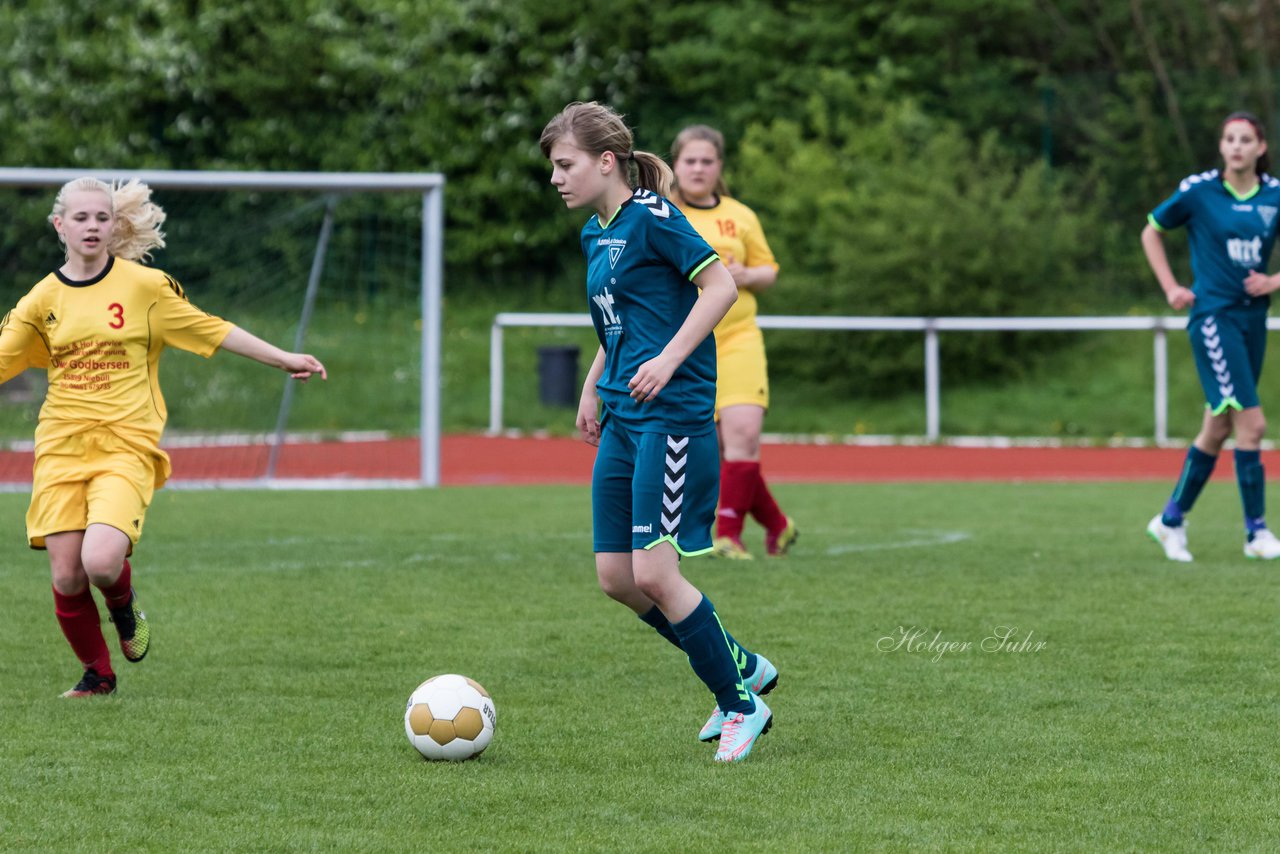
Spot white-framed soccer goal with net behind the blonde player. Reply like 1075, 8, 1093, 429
0, 168, 445, 487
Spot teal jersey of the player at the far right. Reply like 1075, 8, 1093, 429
1147, 169, 1280, 316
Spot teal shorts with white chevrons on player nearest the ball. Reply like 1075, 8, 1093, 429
591, 419, 719, 556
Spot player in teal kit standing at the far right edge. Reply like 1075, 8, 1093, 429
1142, 113, 1280, 561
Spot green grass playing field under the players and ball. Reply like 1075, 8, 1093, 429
0, 484, 1280, 851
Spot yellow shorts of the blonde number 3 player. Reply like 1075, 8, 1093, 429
27, 429, 155, 553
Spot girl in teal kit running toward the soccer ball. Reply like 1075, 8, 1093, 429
540, 102, 778, 762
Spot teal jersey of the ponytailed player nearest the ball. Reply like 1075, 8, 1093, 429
582, 189, 718, 435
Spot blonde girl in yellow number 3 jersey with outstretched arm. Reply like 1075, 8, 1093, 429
0, 178, 325, 697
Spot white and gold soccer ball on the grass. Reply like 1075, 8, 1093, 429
404, 673, 498, 762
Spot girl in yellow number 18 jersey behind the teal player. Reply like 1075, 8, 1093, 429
671, 124, 797, 560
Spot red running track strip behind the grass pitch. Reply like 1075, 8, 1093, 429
0, 435, 1254, 485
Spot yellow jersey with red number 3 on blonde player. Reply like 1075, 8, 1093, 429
0, 257, 233, 487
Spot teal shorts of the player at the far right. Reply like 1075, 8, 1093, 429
1187, 309, 1267, 415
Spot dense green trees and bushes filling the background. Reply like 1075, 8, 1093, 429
0, 0, 1280, 392
